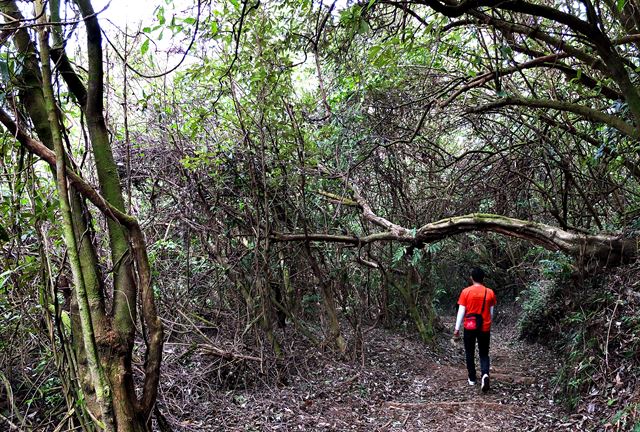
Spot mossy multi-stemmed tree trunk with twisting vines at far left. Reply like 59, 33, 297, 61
0, 0, 163, 431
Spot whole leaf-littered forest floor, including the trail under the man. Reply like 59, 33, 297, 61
160, 317, 595, 432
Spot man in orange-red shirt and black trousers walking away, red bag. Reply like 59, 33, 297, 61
453, 267, 497, 392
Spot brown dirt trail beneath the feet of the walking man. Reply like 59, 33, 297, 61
372, 322, 568, 431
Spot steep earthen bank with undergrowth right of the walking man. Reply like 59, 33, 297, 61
518, 258, 640, 431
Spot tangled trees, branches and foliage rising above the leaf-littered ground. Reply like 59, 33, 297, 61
0, 0, 640, 431
